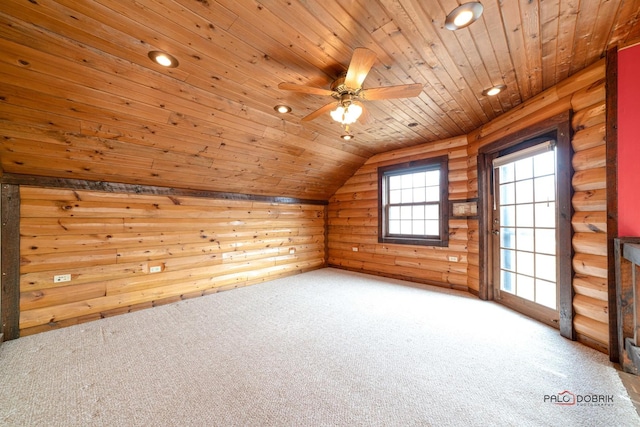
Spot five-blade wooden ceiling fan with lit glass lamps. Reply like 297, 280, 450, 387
278, 47, 423, 126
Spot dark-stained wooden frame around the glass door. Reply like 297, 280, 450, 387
478, 111, 576, 340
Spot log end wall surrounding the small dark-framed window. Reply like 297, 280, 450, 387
328, 137, 470, 290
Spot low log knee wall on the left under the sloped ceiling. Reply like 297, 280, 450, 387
19, 186, 326, 335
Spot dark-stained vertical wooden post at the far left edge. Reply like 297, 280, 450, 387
0, 184, 20, 342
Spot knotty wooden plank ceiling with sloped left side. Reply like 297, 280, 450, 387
0, 0, 640, 200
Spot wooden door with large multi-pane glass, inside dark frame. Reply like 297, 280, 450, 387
492, 141, 558, 327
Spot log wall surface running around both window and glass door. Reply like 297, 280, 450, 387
329, 60, 609, 351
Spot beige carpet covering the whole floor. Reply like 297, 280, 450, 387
0, 269, 640, 427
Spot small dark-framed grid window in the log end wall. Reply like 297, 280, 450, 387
378, 156, 449, 246
